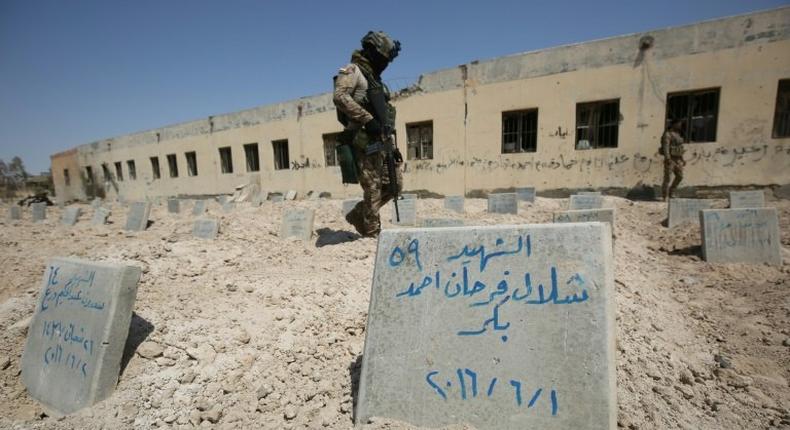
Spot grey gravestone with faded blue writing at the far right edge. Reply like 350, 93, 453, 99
700, 208, 782, 266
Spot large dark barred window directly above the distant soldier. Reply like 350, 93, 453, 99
664, 87, 721, 143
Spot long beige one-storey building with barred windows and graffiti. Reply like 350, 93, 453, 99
51, 7, 790, 200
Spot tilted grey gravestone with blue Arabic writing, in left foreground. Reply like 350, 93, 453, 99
22, 258, 141, 415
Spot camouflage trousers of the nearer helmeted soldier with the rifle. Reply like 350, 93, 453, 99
348, 150, 403, 236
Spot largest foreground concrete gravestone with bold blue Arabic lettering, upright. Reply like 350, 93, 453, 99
356, 223, 617, 430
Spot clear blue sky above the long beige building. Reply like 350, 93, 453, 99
0, 0, 790, 173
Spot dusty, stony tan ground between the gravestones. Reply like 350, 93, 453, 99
0, 197, 790, 430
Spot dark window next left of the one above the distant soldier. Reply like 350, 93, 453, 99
574, 98, 620, 150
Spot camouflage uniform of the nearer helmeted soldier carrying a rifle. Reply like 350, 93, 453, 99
333, 63, 403, 237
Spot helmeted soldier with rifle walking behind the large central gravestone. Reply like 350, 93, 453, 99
333, 31, 403, 237
